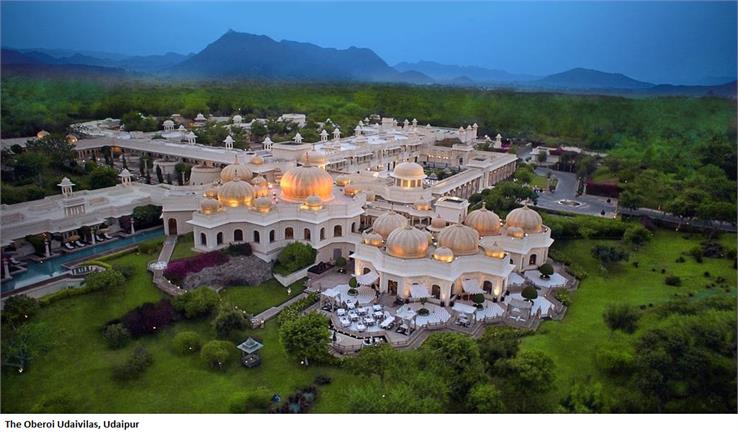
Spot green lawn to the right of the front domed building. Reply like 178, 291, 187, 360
521, 230, 736, 404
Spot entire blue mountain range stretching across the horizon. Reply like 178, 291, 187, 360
0, 30, 736, 98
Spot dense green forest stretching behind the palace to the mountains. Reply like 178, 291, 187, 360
2, 77, 736, 220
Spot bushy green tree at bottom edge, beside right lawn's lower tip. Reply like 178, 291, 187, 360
497, 350, 556, 413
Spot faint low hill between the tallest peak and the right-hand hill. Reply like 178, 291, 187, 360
395, 61, 540, 84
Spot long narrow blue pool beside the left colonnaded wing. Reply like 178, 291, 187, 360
1, 229, 164, 292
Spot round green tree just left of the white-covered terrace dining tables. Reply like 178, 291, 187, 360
279, 312, 330, 364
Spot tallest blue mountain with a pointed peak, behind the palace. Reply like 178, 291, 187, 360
166, 30, 430, 82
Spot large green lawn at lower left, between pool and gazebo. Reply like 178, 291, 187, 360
0, 254, 358, 413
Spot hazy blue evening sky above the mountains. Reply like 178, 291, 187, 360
1, 1, 737, 83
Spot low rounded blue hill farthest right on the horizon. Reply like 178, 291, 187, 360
530, 68, 654, 89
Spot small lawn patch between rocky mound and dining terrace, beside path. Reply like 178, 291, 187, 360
220, 279, 305, 315
